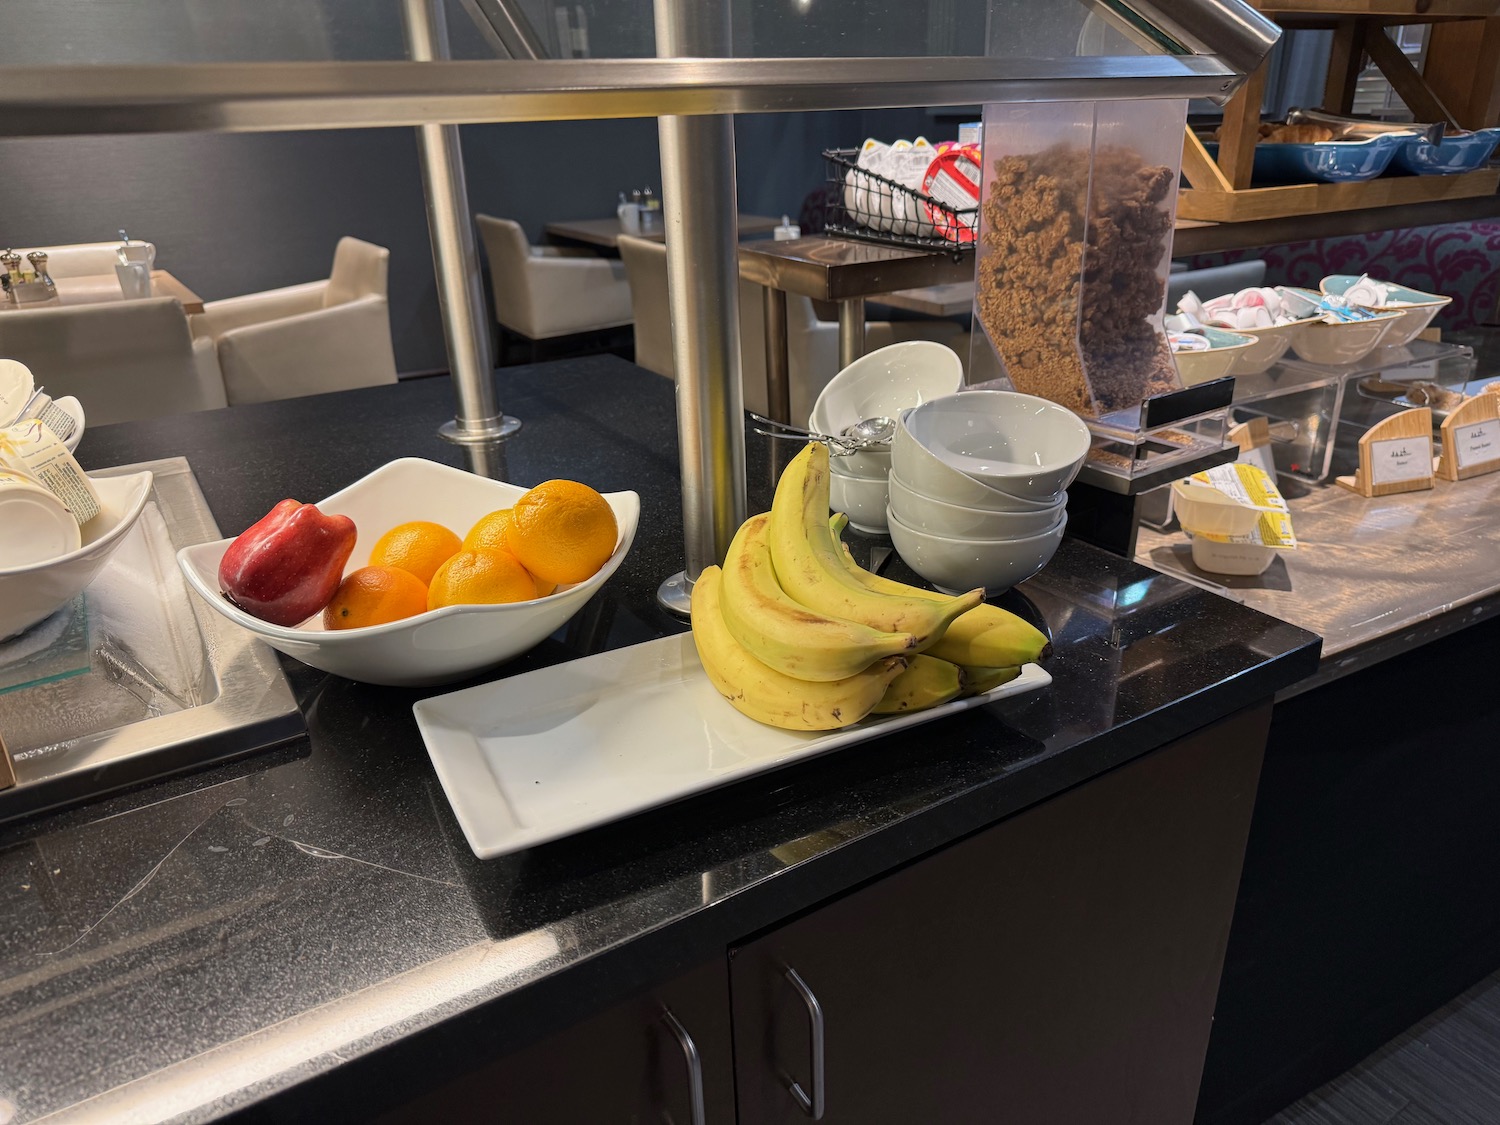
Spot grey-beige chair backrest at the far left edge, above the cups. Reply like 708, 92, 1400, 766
0, 297, 225, 426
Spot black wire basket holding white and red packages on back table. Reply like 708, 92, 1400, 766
824, 149, 980, 258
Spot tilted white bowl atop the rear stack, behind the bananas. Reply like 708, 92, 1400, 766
807, 341, 963, 479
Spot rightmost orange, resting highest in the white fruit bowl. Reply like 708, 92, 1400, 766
506, 480, 620, 585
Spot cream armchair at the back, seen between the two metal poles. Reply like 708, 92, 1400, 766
474, 215, 632, 358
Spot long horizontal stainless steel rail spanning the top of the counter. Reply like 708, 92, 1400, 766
0, 53, 1269, 137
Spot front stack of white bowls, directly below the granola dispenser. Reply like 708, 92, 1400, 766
887, 390, 1089, 593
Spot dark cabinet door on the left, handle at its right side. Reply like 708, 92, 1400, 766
380, 960, 735, 1125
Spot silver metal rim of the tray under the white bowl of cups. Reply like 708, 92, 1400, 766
0, 458, 308, 822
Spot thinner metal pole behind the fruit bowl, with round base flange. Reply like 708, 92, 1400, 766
402, 0, 521, 444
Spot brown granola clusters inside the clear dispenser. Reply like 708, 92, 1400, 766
978, 144, 1179, 417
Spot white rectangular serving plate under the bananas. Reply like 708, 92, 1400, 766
411, 633, 1052, 860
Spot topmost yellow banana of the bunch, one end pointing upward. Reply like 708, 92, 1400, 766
770, 441, 984, 653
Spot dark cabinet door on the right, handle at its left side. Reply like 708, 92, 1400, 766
729, 704, 1271, 1125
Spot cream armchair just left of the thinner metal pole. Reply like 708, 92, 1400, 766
189, 237, 396, 405
